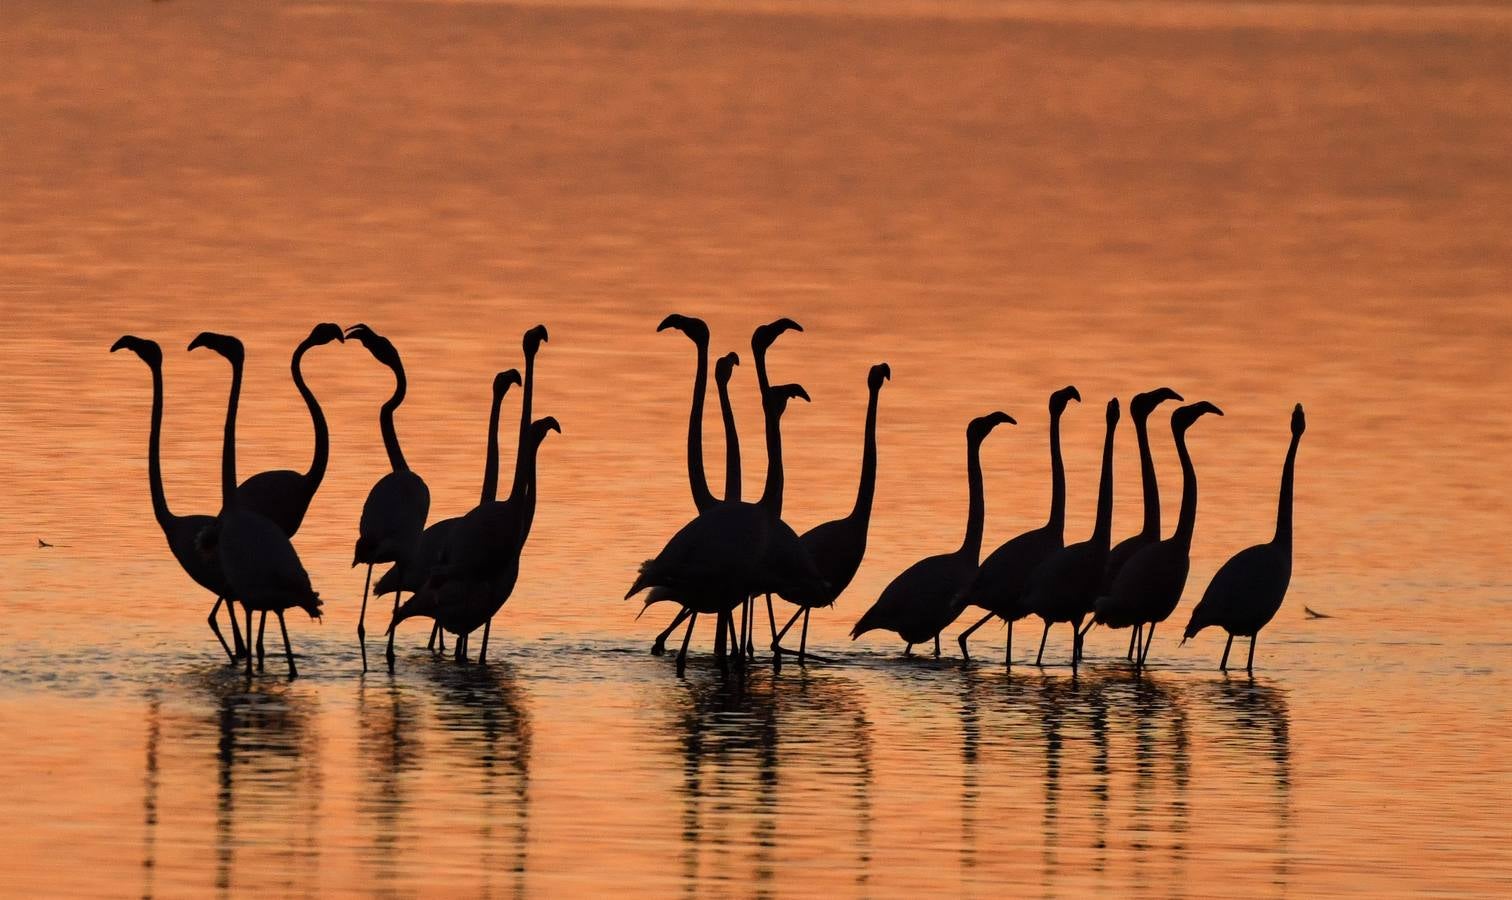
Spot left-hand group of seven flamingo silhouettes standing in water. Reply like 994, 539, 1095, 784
110, 324, 561, 678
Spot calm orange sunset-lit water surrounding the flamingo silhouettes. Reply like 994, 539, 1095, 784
0, 0, 1512, 897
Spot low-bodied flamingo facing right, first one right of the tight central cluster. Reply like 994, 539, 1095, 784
851, 413, 1016, 656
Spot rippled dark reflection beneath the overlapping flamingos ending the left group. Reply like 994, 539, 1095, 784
420, 659, 532, 897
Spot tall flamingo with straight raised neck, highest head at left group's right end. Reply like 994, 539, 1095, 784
414, 325, 561, 663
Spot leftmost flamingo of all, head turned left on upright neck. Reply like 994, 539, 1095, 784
111, 334, 245, 663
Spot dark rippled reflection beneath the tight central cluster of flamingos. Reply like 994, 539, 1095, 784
671, 669, 872, 897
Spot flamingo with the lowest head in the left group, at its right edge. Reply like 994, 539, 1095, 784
389, 416, 561, 663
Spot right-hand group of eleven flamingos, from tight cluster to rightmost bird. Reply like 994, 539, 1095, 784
626, 315, 1306, 673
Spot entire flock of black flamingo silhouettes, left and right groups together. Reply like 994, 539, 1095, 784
110, 315, 1306, 678
